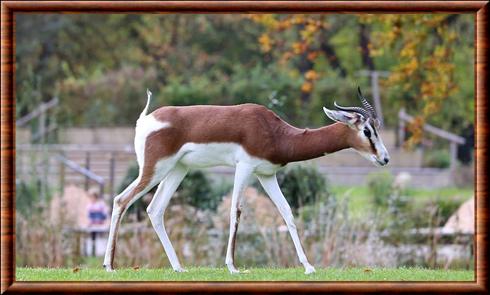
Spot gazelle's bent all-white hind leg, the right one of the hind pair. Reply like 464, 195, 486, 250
146, 165, 188, 272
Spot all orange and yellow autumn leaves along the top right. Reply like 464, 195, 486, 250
248, 14, 470, 145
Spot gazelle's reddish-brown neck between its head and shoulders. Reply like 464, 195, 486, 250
283, 123, 353, 162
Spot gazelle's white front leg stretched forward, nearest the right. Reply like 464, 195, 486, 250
257, 175, 315, 274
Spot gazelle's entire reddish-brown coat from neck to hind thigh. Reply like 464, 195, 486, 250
127, 104, 359, 206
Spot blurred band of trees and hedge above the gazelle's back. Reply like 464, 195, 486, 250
16, 14, 474, 142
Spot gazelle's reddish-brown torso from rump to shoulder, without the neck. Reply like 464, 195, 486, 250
145, 104, 302, 164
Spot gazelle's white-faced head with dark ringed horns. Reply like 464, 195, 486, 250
323, 88, 390, 166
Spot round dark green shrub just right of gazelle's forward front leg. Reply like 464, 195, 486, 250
254, 166, 331, 211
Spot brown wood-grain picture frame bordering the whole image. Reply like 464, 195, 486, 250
1, 1, 489, 294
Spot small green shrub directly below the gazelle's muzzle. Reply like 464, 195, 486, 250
368, 171, 394, 207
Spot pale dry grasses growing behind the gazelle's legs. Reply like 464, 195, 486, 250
17, 188, 396, 267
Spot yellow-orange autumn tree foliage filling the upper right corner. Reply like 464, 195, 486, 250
360, 14, 473, 145
